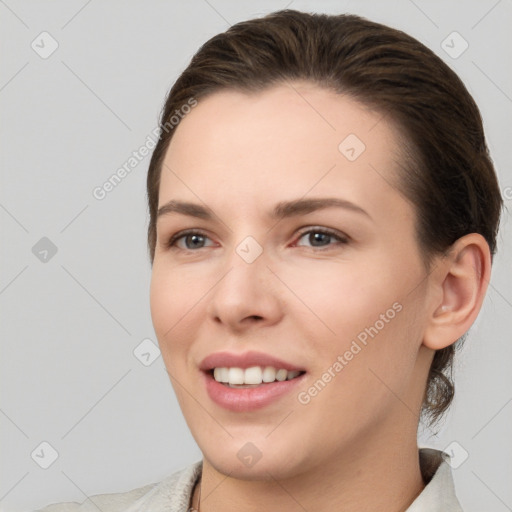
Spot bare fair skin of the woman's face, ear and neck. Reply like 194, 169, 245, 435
151, 82, 490, 511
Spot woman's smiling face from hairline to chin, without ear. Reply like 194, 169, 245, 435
151, 83, 432, 478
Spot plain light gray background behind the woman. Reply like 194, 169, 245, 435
0, 0, 512, 512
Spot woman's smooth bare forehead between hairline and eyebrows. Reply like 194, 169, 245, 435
159, 82, 408, 214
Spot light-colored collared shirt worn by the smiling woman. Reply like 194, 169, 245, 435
38, 448, 462, 512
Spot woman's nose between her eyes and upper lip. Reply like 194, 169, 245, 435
207, 244, 283, 333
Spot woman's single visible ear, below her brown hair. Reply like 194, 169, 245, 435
423, 233, 491, 350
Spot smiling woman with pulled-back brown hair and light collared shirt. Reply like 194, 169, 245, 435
39, 10, 501, 512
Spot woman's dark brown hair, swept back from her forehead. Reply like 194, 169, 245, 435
147, 10, 502, 423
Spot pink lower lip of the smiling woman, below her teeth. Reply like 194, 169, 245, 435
202, 372, 306, 412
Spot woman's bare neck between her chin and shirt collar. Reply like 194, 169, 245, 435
192, 424, 425, 512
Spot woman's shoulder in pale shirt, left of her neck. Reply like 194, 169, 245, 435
36, 462, 201, 512
